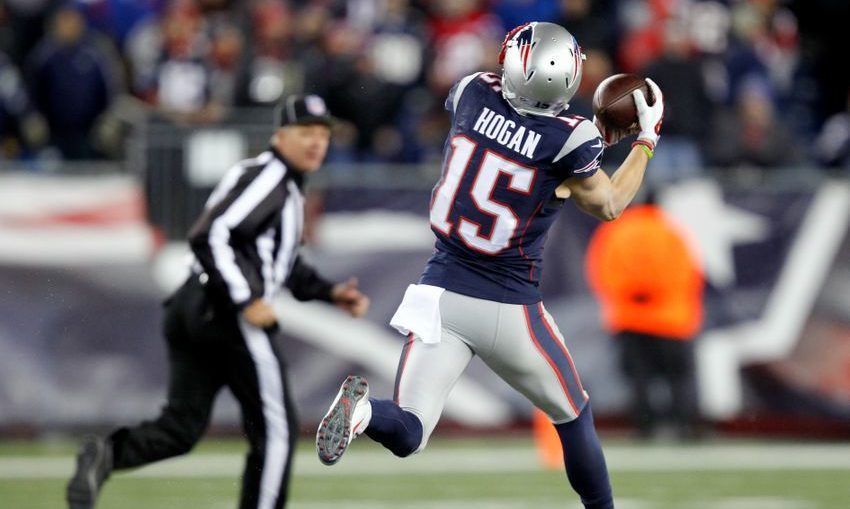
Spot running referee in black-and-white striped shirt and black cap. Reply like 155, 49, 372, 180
67, 95, 369, 509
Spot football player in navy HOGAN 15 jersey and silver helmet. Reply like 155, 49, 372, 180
316, 22, 664, 509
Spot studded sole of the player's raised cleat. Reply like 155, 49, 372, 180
316, 376, 369, 465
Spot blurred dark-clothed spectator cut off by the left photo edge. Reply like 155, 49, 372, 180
0, 51, 47, 160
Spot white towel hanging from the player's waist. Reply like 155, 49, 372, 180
390, 285, 446, 344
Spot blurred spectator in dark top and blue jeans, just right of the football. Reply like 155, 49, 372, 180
642, 19, 712, 183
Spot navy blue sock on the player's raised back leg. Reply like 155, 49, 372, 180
366, 398, 422, 458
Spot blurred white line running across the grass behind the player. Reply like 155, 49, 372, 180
0, 443, 850, 478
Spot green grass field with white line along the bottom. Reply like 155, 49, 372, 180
0, 438, 850, 509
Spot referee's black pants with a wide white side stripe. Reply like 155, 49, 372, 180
111, 277, 298, 509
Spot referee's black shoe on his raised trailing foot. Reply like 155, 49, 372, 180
65, 436, 112, 509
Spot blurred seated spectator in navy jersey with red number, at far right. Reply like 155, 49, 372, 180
706, 80, 799, 168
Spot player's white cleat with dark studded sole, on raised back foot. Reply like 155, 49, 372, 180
316, 376, 372, 465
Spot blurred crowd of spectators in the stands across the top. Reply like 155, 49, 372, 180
0, 0, 850, 179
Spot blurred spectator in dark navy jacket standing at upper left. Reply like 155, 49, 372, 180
27, 4, 123, 159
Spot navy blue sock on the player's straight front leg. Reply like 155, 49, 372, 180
555, 402, 614, 509
